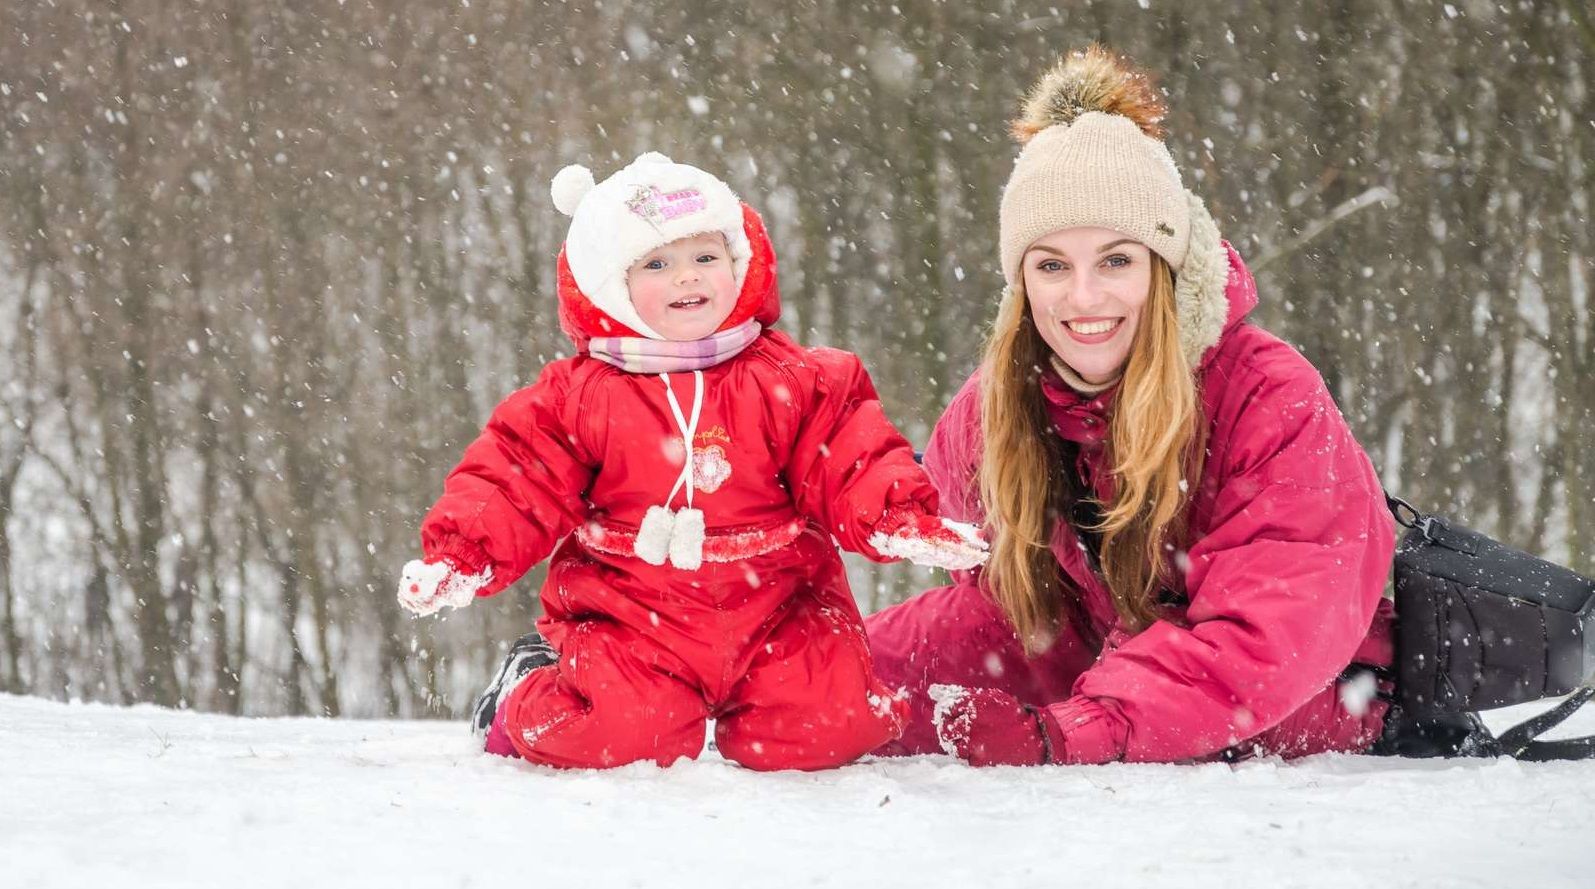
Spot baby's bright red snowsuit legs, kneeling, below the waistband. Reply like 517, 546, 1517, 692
501, 530, 904, 771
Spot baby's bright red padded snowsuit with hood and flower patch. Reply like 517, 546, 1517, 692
421, 209, 936, 769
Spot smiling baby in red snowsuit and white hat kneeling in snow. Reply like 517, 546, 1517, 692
399, 152, 986, 769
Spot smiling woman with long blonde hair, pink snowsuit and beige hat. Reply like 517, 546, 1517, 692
866, 48, 1394, 765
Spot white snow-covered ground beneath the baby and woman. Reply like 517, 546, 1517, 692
0, 696, 1595, 889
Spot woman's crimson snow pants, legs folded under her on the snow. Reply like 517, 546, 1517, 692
864, 584, 1394, 761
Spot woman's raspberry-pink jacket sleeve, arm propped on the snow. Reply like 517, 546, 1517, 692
1048, 356, 1394, 763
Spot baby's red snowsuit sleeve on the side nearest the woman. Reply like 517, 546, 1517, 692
786, 348, 936, 560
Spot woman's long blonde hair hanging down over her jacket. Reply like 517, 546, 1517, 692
979, 254, 1203, 653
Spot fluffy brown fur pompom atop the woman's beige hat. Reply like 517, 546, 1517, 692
1010, 45, 1168, 145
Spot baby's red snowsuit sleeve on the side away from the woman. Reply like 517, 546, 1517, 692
421, 362, 593, 595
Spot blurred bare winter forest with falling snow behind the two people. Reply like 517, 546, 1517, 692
0, 0, 1595, 715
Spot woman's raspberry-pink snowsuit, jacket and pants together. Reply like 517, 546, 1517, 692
866, 242, 1394, 763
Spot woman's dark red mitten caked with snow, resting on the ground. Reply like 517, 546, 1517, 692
928, 685, 1050, 766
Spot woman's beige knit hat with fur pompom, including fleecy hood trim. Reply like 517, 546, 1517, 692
998, 46, 1230, 365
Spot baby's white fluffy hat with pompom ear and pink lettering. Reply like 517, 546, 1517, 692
549, 152, 753, 340
